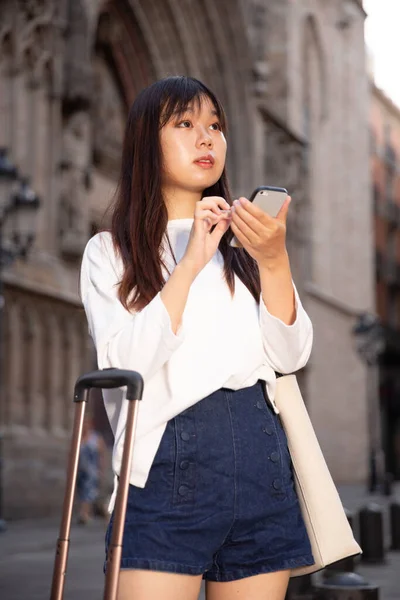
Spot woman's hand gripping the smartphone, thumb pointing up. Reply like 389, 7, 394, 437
231, 196, 291, 267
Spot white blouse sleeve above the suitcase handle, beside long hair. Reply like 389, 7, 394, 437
80, 233, 184, 379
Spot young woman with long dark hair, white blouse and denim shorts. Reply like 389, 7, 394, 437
81, 77, 314, 600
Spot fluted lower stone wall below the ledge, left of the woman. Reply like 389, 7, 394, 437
1, 286, 93, 518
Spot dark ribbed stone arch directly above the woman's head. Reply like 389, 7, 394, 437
85, 0, 254, 193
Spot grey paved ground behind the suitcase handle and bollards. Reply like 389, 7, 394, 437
0, 486, 400, 600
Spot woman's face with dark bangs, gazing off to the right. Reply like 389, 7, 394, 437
160, 98, 226, 193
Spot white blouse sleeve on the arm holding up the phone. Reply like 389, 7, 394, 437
259, 284, 313, 374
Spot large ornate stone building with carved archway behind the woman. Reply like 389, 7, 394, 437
0, 0, 374, 518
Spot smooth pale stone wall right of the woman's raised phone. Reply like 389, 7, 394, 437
288, 0, 375, 482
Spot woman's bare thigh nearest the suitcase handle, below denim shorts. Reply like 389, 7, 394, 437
118, 569, 201, 600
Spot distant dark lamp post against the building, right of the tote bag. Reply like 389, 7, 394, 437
353, 312, 385, 492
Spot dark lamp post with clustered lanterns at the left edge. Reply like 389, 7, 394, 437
0, 148, 40, 531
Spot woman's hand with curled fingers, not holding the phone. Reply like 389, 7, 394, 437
180, 196, 232, 277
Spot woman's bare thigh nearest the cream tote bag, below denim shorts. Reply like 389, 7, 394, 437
206, 570, 290, 600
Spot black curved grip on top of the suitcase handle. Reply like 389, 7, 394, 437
74, 368, 143, 402
